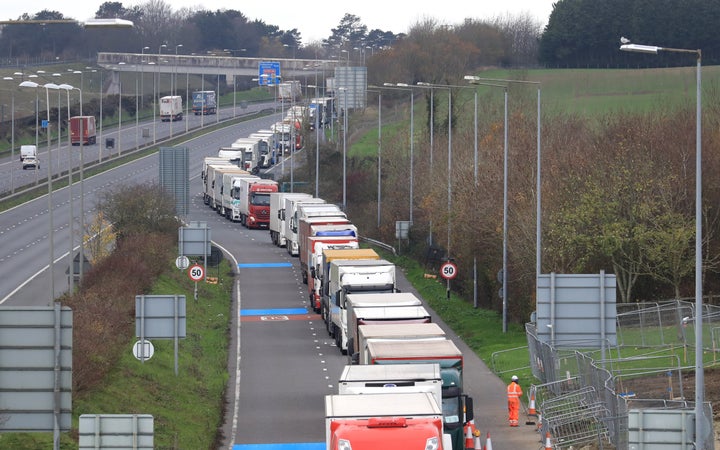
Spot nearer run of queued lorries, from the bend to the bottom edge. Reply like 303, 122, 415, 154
268, 192, 474, 450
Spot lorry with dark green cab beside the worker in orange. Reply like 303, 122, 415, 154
367, 339, 474, 450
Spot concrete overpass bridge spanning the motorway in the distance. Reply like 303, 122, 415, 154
97, 52, 338, 94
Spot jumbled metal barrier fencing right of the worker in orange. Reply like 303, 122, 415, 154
525, 301, 720, 450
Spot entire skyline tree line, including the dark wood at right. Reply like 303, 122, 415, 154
0, 0, 720, 70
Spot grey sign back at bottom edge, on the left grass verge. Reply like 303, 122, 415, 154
78, 414, 155, 450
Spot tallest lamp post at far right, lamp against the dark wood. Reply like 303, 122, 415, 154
620, 38, 706, 450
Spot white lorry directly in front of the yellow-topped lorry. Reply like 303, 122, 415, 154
327, 259, 397, 355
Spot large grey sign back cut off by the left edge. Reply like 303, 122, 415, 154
0, 303, 72, 430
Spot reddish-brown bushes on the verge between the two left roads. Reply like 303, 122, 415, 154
61, 185, 179, 393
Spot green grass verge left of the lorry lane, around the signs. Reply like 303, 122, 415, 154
0, 261, 233, 450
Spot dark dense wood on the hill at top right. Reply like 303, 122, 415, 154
539, 0, 720, 68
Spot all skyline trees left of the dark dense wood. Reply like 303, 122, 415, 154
0, 0, 540, 64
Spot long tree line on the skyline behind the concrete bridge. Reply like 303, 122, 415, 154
0, 0, 402, 62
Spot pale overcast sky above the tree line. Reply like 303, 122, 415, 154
0, 0, 557, 44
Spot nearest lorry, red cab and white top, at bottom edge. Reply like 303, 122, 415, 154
325, 392, 450, 450
